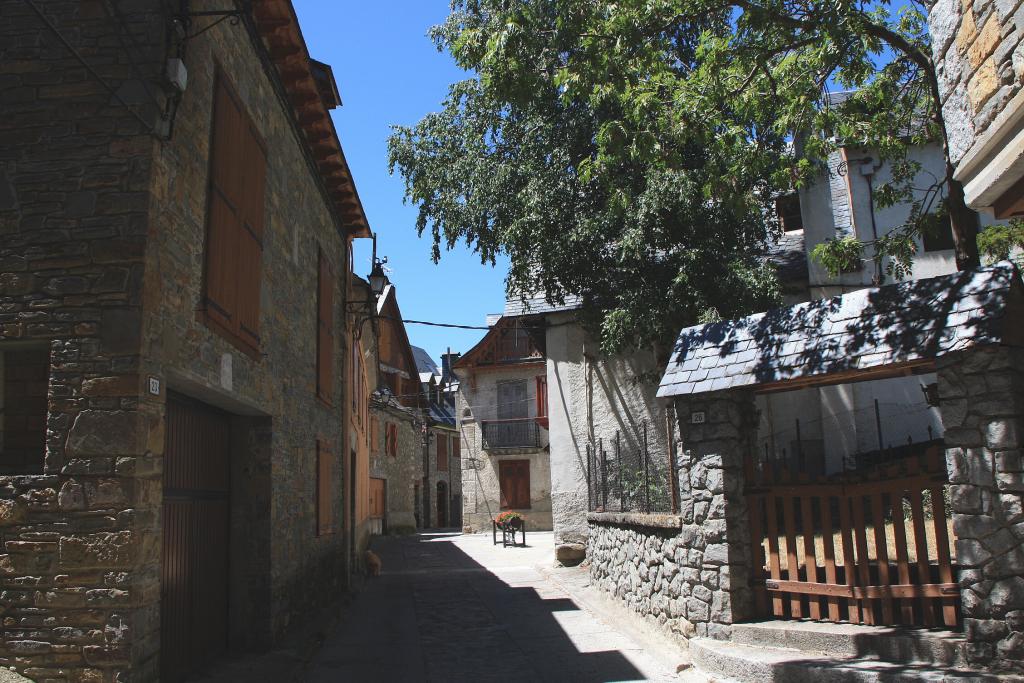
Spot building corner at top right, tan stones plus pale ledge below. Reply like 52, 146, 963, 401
928, 0, 1024, 218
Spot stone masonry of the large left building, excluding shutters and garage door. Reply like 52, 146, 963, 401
0, 0, 358, 683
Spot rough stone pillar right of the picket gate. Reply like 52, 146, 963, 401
938, 347, 1024, 672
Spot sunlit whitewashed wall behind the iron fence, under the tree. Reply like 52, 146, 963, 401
546, 313, 668, 544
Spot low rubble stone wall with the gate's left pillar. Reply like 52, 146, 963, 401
588, 391, 756, 638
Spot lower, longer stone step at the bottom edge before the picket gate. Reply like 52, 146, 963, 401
690, 638, 1001, 683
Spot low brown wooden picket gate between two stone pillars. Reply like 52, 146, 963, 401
745, 445, 959, 627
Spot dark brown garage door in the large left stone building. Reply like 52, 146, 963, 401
160, 395, 229, 682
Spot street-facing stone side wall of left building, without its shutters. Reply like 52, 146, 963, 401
141, 0, 350, 640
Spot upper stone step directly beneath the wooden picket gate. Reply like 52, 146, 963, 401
732, 621, 967, 668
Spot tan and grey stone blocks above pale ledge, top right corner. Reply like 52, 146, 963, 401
928, 0, 1024, 165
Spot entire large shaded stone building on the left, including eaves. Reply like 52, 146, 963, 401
0, 0, 369, 681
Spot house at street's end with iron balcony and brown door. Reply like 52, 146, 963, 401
452, 317, 552, 531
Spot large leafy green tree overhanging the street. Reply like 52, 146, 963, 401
390, 0, 977, 350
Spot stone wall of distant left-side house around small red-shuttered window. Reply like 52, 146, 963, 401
370, 401, 423, 532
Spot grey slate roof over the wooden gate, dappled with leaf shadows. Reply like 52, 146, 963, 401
657, 262, 1024, 397
